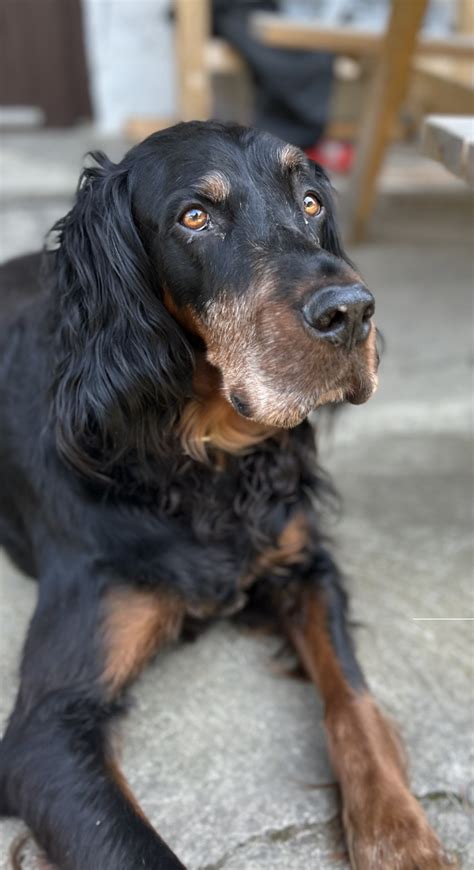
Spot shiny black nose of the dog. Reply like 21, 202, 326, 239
303, 284, 375, 349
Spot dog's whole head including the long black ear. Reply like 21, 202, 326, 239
51, 122, 377, 474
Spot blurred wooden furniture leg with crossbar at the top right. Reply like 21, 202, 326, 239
250, 0, 474, 242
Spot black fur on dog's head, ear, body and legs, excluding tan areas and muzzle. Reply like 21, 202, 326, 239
0, 123, 370, 870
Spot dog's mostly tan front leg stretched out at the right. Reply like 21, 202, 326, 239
272, 553, 451, 870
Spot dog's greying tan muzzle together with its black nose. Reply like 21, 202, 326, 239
191, 282, 378, 429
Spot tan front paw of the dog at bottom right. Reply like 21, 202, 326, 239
343, 789, 456, 870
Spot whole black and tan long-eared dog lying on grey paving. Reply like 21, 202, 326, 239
0, 122, 446, 870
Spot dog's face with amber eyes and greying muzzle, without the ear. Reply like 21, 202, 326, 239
131, 122, 377, 427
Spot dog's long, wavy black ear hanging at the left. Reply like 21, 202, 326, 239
53, 152, 193, 474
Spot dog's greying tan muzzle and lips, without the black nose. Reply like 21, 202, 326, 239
167, 284, 378, 429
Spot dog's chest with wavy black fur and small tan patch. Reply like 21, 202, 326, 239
111, 427, 318, 616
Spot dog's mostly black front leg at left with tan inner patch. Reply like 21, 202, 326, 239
0, 576, 183, 870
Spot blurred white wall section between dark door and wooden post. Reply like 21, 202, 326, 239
82, 0, 176, 133
